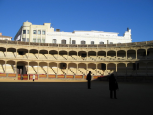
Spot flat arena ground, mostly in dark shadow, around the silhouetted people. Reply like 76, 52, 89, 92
0, 81, 153, 115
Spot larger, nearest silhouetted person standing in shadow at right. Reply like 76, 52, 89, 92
109, 74, 118, 99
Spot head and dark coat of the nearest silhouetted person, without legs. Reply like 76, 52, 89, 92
109, 74, 118, 90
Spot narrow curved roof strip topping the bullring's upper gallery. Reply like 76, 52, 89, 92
0, 40, 153, 48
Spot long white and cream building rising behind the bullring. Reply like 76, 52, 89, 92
14, 21, 132, 44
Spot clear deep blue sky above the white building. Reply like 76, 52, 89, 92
0, 0, 153, 42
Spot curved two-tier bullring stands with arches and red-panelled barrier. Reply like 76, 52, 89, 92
0, 40, 153, 81
